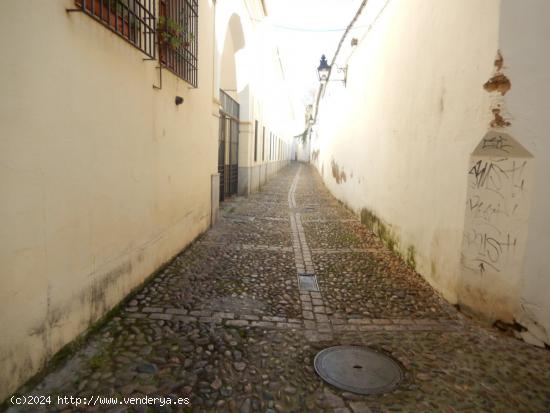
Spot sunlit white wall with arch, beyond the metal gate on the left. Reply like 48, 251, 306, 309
215, 0, 295, 195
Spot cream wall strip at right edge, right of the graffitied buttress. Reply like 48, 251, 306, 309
500, 0, 550, 343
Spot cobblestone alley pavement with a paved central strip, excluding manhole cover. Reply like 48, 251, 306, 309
7, 165, 550, 413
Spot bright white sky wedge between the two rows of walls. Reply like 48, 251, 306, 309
266, 0, 361, 109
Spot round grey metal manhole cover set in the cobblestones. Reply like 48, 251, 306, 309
313, 346, 403, 394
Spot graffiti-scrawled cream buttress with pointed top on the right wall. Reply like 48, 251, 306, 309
462, 132, 532, 275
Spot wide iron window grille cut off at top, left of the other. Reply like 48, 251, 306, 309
70, 0, 156, 58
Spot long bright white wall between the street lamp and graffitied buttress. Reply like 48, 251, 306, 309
312, 0, 499, 302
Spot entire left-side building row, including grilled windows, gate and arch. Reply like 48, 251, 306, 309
0, 0, 293, 399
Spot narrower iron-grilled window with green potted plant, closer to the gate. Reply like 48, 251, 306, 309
157, 0, 199, 87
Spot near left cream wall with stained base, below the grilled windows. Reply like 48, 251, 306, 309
0, 0, 218, 400
